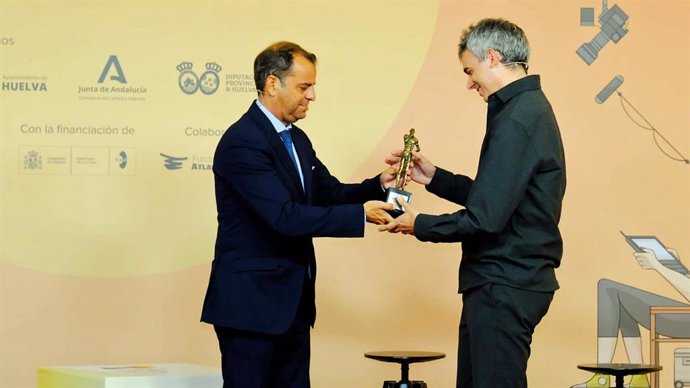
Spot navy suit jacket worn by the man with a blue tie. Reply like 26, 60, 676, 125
201, 102, 384, 334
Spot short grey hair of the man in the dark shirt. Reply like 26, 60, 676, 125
458, 19, 529, 64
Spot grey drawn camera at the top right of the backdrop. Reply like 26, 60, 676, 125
577, 0, 628, 65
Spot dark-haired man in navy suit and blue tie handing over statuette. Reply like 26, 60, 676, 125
201, 42, 395, 388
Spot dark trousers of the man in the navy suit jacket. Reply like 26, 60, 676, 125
214, 281, 315, 388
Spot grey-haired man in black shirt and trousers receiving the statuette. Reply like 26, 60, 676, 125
380, 19, 566, 388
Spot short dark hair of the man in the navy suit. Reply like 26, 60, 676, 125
254, 41, 316, 93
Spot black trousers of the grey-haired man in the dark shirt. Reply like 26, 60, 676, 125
457, 284, 553, 388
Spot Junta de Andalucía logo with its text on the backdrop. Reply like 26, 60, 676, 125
77, 55, 147, 101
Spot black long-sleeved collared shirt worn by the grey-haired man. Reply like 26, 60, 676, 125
414, 75, 566, 292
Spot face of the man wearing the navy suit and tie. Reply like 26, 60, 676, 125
276, 55, 316, 124
